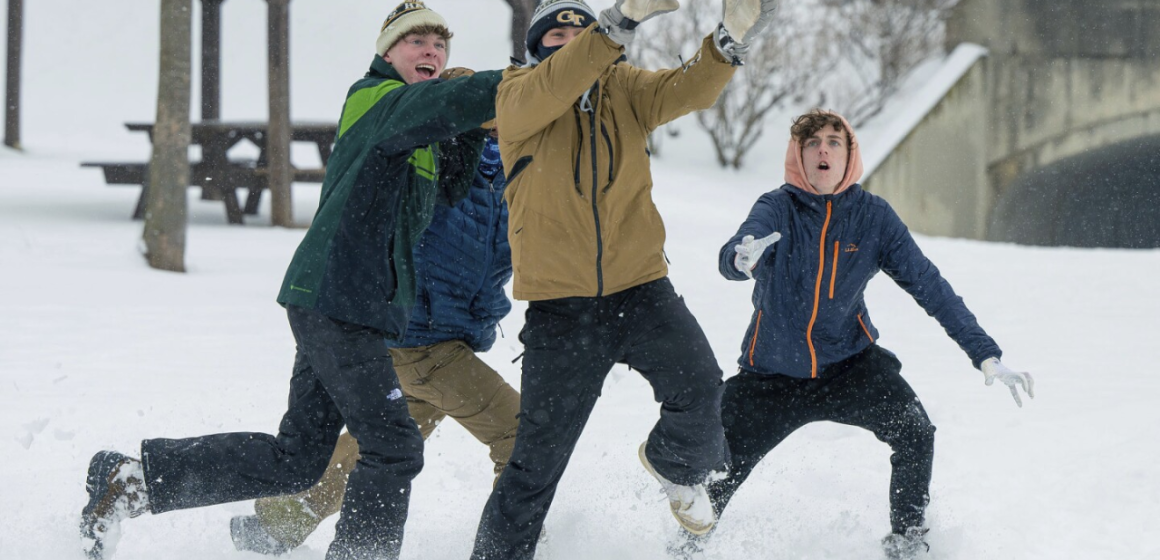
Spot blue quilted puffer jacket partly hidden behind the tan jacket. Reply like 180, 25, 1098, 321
389, 162, 512, 352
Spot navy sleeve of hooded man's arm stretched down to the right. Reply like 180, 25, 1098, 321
878, 205, 1002, 368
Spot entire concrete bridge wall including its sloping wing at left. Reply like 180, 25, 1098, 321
865, 0, 1160, 246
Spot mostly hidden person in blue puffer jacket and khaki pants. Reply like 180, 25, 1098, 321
230, 129, 520, 554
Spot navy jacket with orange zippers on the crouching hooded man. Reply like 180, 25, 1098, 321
719, 184, 1001, 378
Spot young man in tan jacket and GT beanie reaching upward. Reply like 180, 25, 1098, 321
472, 0, 776, 560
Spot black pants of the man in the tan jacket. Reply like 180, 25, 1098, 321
471, 278, 727, 560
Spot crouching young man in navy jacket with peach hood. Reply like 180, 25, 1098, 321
709, 110, 1035, 559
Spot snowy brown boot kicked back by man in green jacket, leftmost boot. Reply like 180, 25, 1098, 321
80, 451, 148, 560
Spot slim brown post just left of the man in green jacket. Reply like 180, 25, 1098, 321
266, 0, 293, 227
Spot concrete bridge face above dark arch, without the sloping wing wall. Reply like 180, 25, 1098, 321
948, 0, 1160, 192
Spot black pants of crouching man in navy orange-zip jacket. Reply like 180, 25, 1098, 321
709, 346, 935, 533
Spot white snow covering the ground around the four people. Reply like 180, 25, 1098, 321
0, 0, 1160, 560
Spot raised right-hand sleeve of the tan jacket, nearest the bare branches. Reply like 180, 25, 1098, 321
628, 35, 737, 131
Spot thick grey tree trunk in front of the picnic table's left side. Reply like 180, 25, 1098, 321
144, 0, 193, 272
